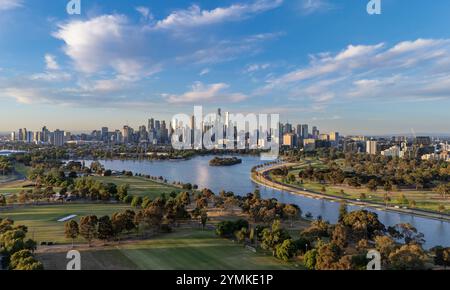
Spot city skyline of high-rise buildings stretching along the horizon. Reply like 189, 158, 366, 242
9, 109, 450, 162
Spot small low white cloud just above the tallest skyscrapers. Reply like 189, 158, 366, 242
164, 82, 247, 104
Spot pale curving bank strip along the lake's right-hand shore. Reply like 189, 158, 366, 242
251, 163, 450, 222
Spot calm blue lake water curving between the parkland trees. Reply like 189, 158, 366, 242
86, 156, 450, 248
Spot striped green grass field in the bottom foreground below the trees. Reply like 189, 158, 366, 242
37, 229, 295, 270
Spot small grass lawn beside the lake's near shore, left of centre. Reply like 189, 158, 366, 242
93, 176, 182, 199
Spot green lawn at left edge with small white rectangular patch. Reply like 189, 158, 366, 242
0, 204, 130, 244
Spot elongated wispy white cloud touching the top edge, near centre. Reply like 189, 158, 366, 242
155, 0, 283, 29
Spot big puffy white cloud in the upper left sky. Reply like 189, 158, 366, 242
53, 15, 158, 79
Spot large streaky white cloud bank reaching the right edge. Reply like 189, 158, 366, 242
256, 39, 450, 106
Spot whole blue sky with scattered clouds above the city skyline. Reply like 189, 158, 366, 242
0, 0, 450, 135
